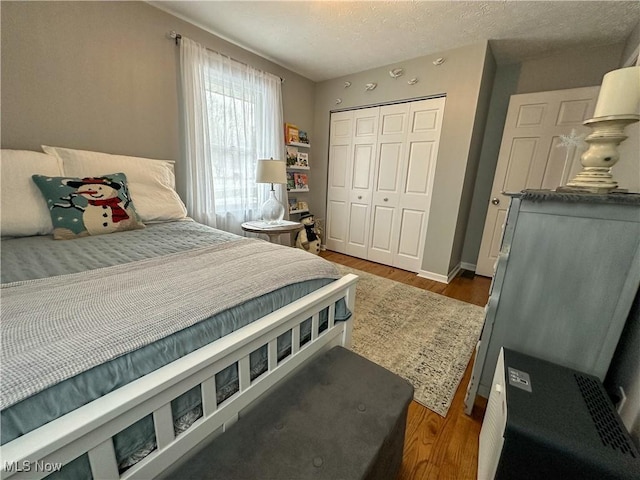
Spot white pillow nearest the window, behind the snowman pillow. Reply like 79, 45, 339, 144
42, 145, 187, 223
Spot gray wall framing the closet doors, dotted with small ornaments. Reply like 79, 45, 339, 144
311, 42, 494, 276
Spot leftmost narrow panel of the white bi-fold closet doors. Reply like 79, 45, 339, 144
325, 111, 353, 253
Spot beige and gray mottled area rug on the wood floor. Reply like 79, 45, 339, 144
335, 263, 484, 417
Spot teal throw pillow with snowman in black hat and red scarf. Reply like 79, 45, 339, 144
32, 173, 144, 240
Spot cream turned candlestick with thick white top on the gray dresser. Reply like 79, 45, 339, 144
567, 66, 640, 193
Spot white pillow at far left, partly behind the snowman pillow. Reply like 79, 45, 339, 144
0, 149, 62, 237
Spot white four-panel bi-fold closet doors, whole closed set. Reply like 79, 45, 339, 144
326, 97, 445, 272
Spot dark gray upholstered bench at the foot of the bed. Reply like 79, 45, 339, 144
166, 347, 413, 480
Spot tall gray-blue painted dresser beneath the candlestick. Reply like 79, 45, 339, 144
465, 190, 640, 413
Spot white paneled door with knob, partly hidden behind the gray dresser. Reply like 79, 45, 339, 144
476, 87, 600, 277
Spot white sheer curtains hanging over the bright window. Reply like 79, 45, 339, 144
180, 37, 287, 234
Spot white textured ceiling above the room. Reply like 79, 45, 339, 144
149, 0, 640, 81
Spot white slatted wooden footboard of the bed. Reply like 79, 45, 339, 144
0, 274, 358, 480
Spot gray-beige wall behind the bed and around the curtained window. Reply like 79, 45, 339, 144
0, 1, 315, 199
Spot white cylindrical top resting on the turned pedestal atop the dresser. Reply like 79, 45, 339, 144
593, 66, 640, 118
